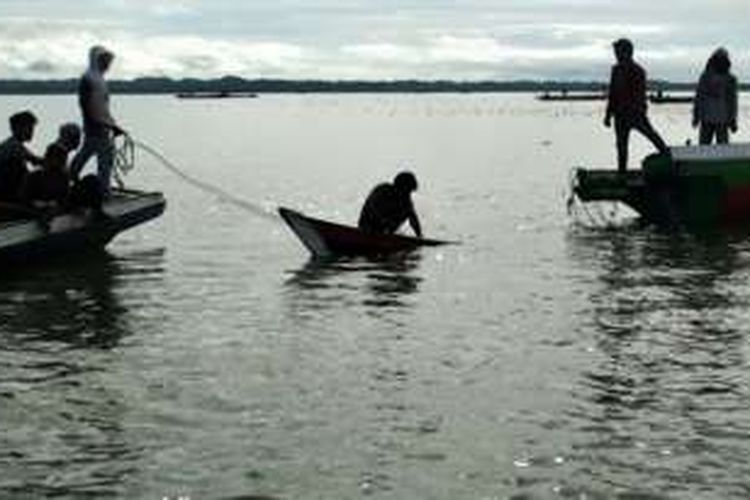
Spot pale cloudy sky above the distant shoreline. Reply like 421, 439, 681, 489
0, 0, 750, 81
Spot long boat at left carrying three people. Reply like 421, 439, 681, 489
0, 189, 166, 266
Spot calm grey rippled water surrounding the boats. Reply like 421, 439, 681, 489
0, 95, 750, 499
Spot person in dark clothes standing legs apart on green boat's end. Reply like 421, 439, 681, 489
604, 38, 669, 172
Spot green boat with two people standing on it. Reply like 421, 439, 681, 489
573, 143, 750, 230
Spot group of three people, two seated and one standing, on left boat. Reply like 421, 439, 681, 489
0, 46, 125, 221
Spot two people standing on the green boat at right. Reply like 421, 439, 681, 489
604, 38, 739, 172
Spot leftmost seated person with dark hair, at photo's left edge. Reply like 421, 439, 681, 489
0, 111, 42, 204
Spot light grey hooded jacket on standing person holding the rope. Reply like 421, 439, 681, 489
78, 45, 115, 135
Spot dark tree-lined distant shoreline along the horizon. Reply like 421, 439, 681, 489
0, 76, 750, 95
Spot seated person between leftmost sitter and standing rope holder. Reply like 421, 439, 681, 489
23, 123, 81, 208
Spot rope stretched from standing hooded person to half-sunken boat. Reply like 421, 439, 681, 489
115, 136, 278, 221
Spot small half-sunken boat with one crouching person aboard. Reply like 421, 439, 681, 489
278, 207, 451, 259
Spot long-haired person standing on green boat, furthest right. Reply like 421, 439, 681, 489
693, 47, 737, 144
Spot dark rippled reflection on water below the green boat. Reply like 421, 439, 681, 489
567, 231, 750, 498
